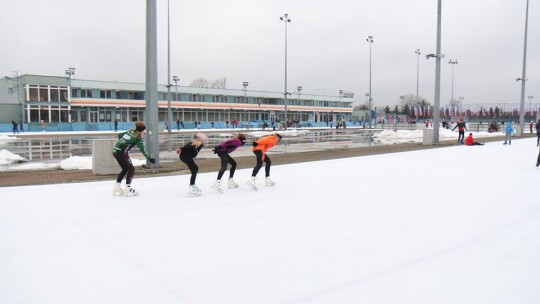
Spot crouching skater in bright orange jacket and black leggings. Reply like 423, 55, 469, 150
247, 133, 281, 190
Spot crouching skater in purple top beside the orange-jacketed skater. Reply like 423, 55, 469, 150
212, 133, 246, 192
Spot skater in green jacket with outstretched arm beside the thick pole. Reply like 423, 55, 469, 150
113, 121, 156, 196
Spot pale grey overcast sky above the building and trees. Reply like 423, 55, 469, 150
0, 0, 540, 105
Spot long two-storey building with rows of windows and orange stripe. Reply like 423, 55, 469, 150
0, 74, 353, 129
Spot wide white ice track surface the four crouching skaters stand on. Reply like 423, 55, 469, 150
0, 138, 540, 304
